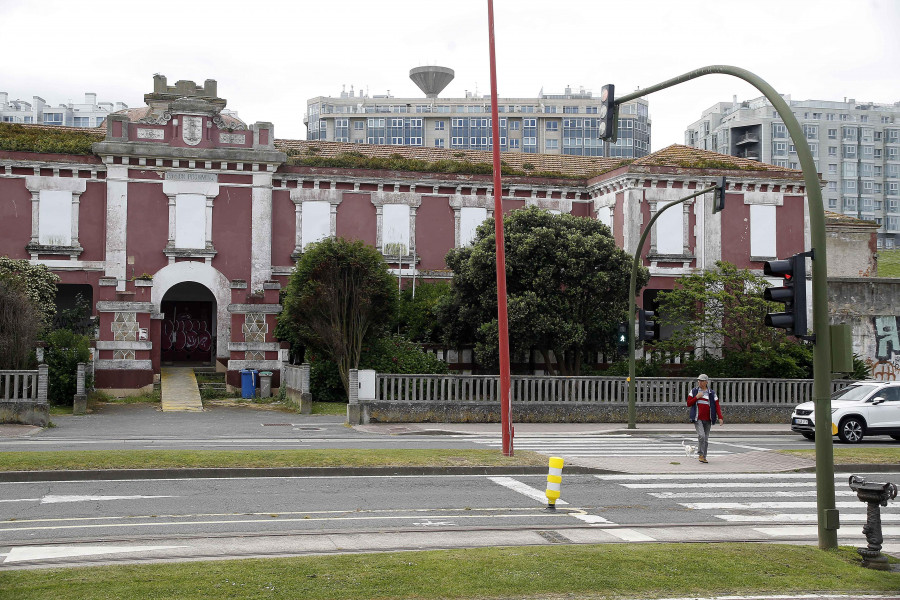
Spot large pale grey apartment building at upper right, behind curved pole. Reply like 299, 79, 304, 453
684, 96, 900, 248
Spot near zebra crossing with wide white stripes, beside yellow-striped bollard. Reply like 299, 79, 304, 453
595, 473, 900, 528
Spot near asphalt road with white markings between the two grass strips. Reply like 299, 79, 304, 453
0, 472, 900, 569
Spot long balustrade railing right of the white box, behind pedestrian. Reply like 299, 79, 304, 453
375, 374, 853, 406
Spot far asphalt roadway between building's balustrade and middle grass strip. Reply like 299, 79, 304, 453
0, 404, 897, 456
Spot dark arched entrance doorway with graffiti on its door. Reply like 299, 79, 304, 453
160, 281, 217, 366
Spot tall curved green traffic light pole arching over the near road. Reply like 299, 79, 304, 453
616, 65, 840, 550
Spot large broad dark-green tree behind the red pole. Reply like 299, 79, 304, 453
437, 207, 648, 375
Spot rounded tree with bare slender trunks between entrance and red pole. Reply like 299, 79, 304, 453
279, 238, 397, 396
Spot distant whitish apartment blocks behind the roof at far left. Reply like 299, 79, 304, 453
0, 92, 128, 127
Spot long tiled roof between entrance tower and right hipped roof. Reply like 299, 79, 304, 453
275, 140, 623, 179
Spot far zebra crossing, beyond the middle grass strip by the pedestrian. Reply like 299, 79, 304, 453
465, 434, 731, 458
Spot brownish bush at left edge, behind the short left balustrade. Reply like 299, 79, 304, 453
0, 277, 41, 370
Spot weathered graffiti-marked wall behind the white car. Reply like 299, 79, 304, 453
828, 277, 900, 381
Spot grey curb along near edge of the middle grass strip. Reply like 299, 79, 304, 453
0, 466, 622, 483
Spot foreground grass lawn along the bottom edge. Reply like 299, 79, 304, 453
0, 543, 900, 600
